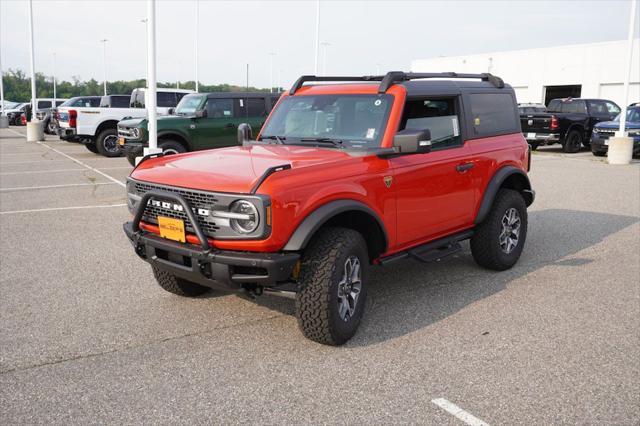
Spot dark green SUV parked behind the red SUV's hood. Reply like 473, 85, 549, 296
118, 92, 280, 165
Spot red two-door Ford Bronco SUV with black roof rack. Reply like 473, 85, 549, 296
124, 72, 534, 345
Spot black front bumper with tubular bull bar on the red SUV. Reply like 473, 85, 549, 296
123, 192, 300, 290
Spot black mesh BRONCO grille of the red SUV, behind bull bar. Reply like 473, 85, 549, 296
135, 182, 220, 237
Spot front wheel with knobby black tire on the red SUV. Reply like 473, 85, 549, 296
296, 228, 369, 345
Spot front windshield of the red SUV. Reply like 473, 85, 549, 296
261, 94, 393, 148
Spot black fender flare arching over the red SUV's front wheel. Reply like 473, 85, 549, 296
282, 200, 389, 252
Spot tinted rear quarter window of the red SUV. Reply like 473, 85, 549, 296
469, 93, 520, 136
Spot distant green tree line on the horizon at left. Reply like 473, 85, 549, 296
2, 69, 269, 102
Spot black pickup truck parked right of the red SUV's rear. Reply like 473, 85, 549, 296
520, 98, 620, 153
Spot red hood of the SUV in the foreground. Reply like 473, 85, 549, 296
131, 145, 359, 193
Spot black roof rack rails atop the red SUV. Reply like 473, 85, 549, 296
289, 71, 504, 95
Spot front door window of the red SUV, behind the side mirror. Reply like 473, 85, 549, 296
400, 99, 462, 150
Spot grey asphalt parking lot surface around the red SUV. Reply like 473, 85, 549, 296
0, 127, 640, 425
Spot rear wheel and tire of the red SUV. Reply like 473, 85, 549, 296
471, 189, 528, 271
